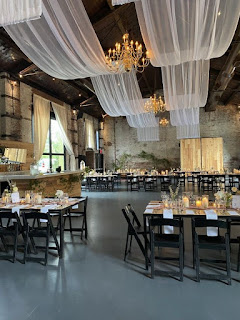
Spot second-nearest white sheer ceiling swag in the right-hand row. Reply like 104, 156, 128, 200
161, 60, 210, 110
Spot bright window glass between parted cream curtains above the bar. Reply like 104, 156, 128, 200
39, 118, 65, 172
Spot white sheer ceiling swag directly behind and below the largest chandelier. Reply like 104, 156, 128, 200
91, 71, 144, 117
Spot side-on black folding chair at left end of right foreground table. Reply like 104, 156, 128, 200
122, 205, 147, 261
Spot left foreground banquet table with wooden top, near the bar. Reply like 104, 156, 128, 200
0, 198, 85, 258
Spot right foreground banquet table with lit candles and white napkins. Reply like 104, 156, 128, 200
143, 201, 240, 269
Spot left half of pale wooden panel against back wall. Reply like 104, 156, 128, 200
180, 139, 201, 171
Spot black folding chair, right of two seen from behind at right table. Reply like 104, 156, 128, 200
192, 218, 231, 284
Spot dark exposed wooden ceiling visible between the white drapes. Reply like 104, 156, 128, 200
0, 0, 240, 118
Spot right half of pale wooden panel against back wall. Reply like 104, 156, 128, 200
201, 138, 223, 171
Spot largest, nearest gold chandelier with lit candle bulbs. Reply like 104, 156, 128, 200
105, 33, 150, 72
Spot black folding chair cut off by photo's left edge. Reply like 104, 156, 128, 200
0, 210, 24, 263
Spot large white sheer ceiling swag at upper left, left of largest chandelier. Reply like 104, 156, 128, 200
5, 0, 109, 79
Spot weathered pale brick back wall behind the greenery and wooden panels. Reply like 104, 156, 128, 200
103, 105, 240, 169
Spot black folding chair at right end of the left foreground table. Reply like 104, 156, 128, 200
64, 197, 88, 239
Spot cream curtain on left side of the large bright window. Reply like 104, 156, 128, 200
33, 94, 50, 161
